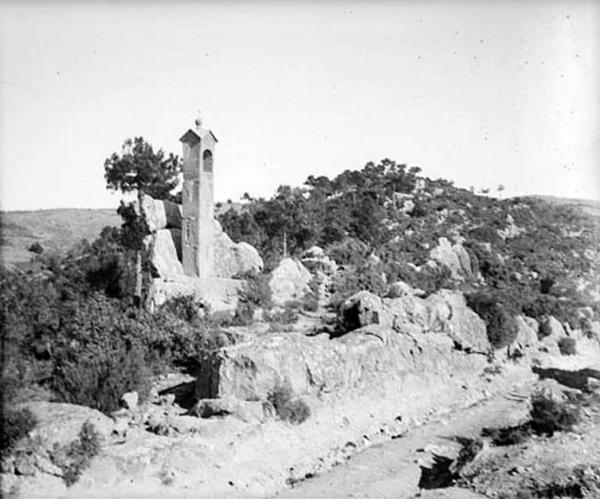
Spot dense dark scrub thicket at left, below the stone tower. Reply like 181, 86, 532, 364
0, 229, 232, 413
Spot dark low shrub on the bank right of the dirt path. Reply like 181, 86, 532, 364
530, 395, 580, 437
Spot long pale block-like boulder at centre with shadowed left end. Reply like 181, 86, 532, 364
196, 326, 411, 401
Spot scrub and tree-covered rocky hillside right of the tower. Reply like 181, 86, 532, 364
220, 159, 600, 336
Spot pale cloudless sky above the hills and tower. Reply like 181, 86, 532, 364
0, 0, 600, 210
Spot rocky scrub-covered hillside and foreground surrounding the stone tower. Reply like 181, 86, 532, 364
0, 160, 600, 498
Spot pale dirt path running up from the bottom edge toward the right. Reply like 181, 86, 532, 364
277, 388, 531, 499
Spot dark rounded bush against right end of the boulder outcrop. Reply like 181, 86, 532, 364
467, 292, 519, 348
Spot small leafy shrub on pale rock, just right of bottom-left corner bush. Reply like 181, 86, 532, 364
50, 422, 100, 486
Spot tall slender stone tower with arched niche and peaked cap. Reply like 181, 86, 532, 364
179, 114, 218, 277
